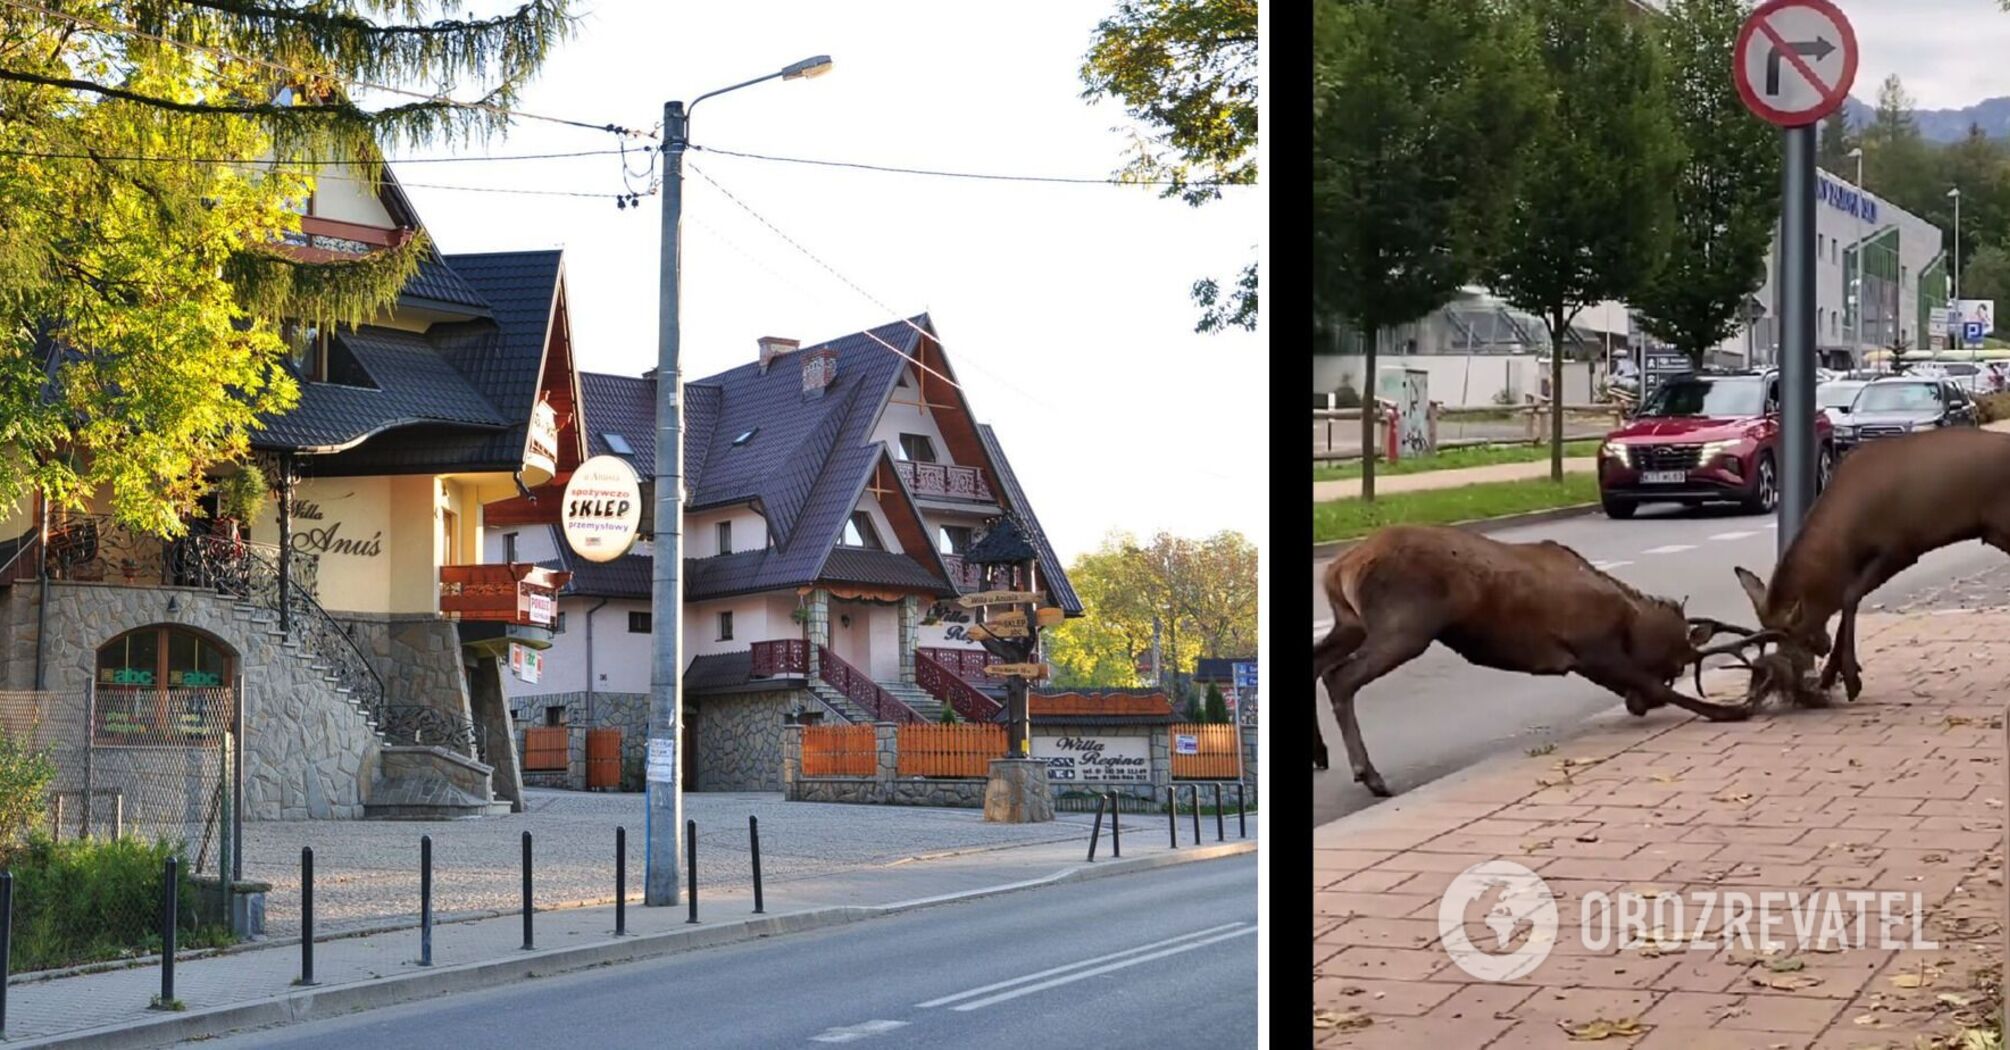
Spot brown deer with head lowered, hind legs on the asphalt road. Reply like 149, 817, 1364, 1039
1313, 525, 1767, 799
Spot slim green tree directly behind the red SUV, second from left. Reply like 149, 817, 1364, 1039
1487, 0, 1682, 483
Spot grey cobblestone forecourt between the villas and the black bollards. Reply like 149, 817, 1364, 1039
245, 789, 1091, 935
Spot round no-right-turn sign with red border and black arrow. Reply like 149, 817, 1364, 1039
1731, 0, 1857, 127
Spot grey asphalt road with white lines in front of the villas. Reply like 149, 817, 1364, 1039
189, 853, 1256, 1050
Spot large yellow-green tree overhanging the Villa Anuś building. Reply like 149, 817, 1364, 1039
0, 0, 571, 533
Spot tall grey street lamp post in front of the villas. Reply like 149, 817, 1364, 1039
643, 54, 830, 905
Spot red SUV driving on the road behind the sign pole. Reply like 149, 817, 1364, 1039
1598, 370, 1835, 517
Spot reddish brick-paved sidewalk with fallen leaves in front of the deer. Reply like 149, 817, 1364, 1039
1313, 607, 2010, 1050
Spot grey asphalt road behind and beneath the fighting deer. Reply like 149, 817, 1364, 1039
1313, 507, 2010, 827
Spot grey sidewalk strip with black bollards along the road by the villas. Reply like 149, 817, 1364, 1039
6, 807, 1258, 1046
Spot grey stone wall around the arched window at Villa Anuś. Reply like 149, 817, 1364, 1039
11, 581, 378, 821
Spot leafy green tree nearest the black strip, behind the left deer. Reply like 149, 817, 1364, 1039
1313, 0, 1546, 499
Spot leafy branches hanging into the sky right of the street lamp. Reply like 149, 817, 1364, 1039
1081, 0, 1256, 332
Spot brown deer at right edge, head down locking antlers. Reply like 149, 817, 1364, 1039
1735, 428, 2010, 704
